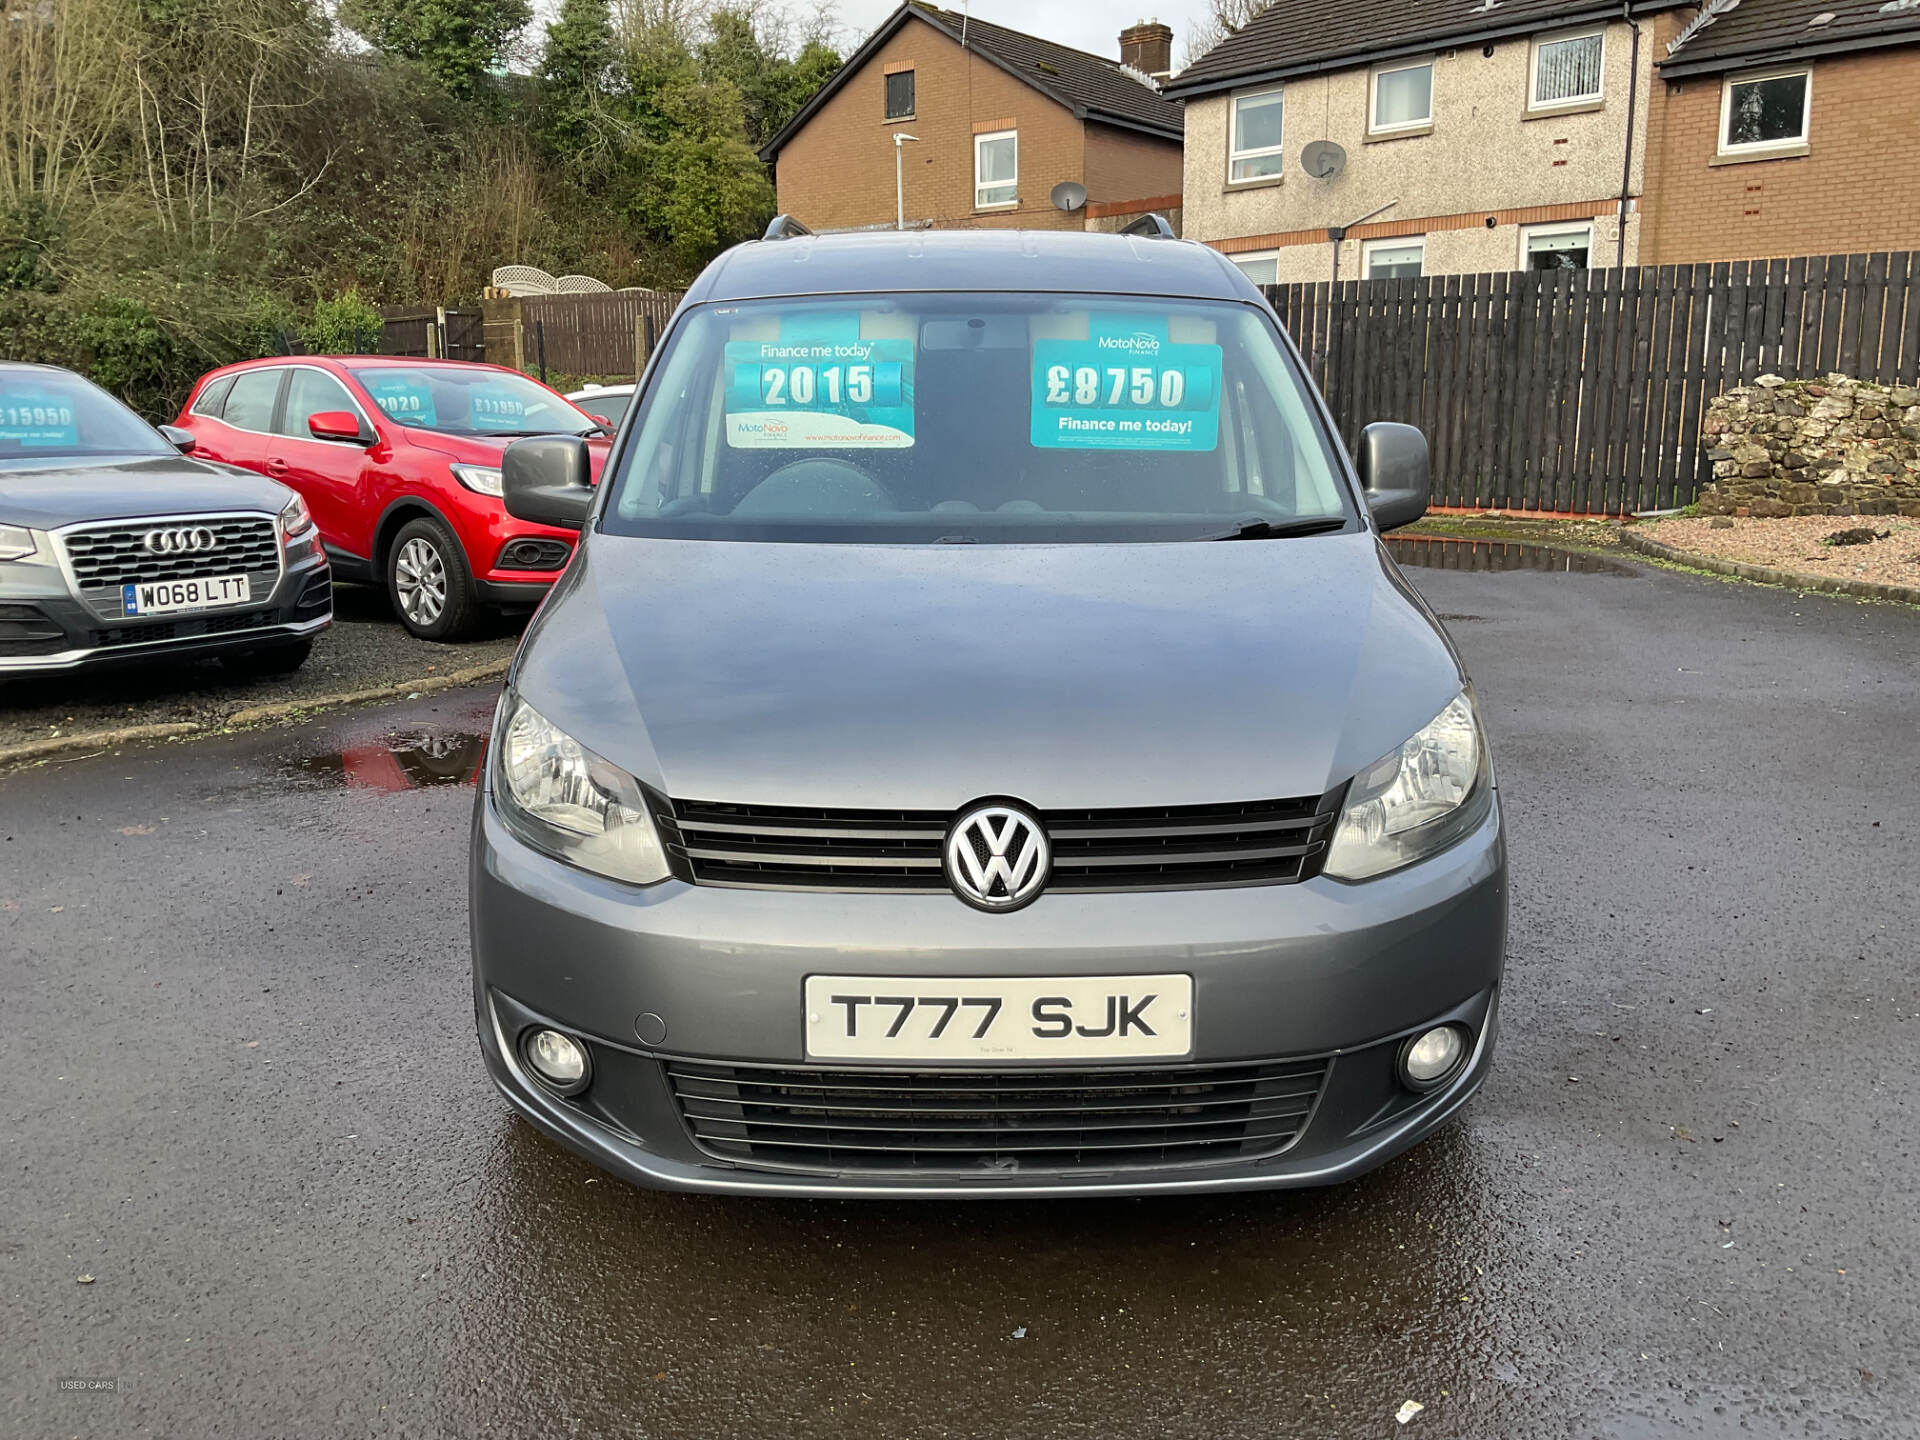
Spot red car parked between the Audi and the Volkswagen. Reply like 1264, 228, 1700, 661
179, 355, 607, 639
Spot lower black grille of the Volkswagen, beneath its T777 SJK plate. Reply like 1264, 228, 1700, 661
664, 1060, 1329, 1177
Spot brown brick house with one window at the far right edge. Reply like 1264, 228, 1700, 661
1642, 0, 1920, 265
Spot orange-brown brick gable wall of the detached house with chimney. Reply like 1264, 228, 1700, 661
776, 19, 1181, 230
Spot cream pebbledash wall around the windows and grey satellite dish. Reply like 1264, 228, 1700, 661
1183, 12, 1680, 284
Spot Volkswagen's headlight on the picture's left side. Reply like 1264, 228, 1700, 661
497, 693, 672, 885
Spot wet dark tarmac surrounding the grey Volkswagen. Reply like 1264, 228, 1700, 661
0, 568, 1920, 1440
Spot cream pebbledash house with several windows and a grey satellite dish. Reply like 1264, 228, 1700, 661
1165, 0, 1689, 284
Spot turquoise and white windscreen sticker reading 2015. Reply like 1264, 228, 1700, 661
726, 338, 914, 449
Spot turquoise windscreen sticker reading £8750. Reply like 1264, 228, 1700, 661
1031, 332, 1221, 451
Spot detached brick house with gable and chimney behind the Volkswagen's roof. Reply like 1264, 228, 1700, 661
760, 0, 1181, 230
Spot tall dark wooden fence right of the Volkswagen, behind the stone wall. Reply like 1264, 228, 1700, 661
1267, 252, 1920, 515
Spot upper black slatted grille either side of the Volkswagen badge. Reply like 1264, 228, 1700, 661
660, 789, 1342, 893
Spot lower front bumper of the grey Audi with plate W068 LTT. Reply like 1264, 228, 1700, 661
0, 545, 334, 678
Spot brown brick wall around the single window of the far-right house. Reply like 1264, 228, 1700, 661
1644, 44, 1920, 265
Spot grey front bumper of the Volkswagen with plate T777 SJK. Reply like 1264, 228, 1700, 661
470, 783, 1507, 1198
